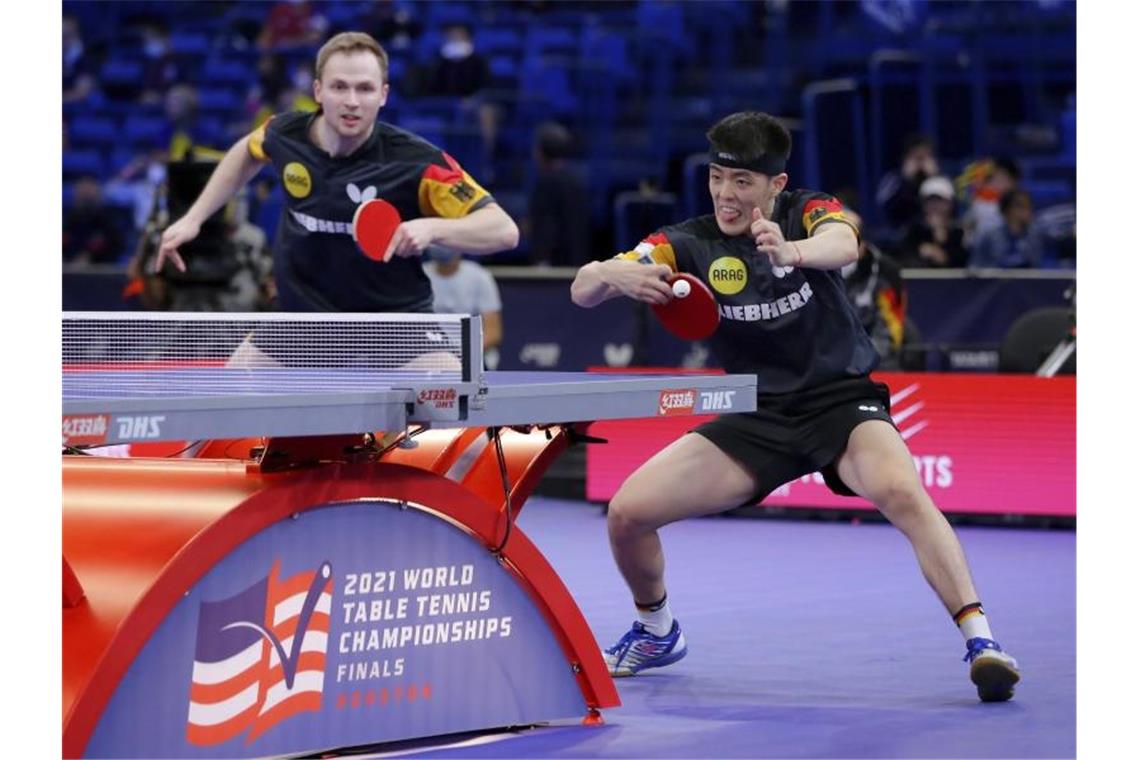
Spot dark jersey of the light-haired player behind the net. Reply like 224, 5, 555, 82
250, 112, 494, 312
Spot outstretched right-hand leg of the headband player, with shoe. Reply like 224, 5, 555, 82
836, 420, 1019, 702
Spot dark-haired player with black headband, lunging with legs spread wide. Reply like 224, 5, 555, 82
571, 112, 1019, 702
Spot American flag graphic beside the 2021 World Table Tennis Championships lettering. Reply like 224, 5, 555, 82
186, 559, 333, 745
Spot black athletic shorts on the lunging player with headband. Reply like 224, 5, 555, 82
692, 377, 895, 504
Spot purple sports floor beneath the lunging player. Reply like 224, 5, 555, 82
362, 498, 1076, 759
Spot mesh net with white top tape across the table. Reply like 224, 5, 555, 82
63, 312, 471, 399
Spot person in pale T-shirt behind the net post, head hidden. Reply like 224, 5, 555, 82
424, 245, 503, 369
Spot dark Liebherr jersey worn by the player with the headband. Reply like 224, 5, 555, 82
619, 190, 878, 394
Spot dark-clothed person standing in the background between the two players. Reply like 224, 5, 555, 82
528, 122, 591, 267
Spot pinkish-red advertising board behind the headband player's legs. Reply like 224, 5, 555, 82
586, 373, 1076, 516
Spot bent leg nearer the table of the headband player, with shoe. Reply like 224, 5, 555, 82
605, 434, 757, 676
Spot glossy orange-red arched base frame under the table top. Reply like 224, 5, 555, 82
63, 426, 620, 757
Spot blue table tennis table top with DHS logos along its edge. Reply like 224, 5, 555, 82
63, 367, 756, 443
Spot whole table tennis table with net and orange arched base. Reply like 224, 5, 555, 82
63, 312, 756, 757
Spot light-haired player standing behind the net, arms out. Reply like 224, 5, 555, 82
155, 32, 519, 312
